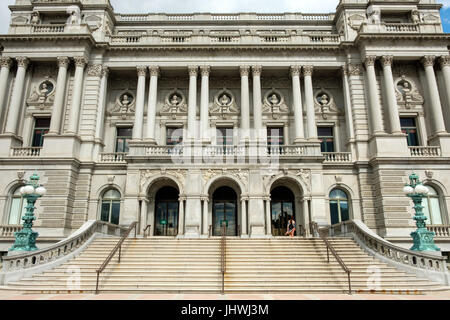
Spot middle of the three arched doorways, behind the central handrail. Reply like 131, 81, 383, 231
212, 187, 238, 236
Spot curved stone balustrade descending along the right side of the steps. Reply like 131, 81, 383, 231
323, 221, 447, 272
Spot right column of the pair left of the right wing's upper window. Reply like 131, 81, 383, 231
381, 56, 402, 134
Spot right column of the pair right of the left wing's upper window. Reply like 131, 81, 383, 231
67, 57, 87, 134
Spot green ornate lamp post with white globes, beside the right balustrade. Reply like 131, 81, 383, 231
403, 173, 440, 251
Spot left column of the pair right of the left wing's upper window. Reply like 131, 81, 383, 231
49, 57, 69, 134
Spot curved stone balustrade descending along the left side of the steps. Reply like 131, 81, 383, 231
2, 221, 128, 272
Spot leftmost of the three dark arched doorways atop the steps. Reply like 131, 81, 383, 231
154, 187, 180, 236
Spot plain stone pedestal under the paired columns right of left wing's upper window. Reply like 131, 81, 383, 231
41, 134, 81, 158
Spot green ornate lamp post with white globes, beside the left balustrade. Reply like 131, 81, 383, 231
9, 173, 47, 252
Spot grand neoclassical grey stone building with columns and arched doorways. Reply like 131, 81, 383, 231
0, 0, 450, 251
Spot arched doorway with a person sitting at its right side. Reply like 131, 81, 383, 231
270, 186, 299, 236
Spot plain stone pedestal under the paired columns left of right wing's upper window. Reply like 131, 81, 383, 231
369, 133, 410, 158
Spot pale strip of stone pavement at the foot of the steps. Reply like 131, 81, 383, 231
0, 291, 450, 301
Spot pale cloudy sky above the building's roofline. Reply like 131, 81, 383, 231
0, 0, 450, 34
